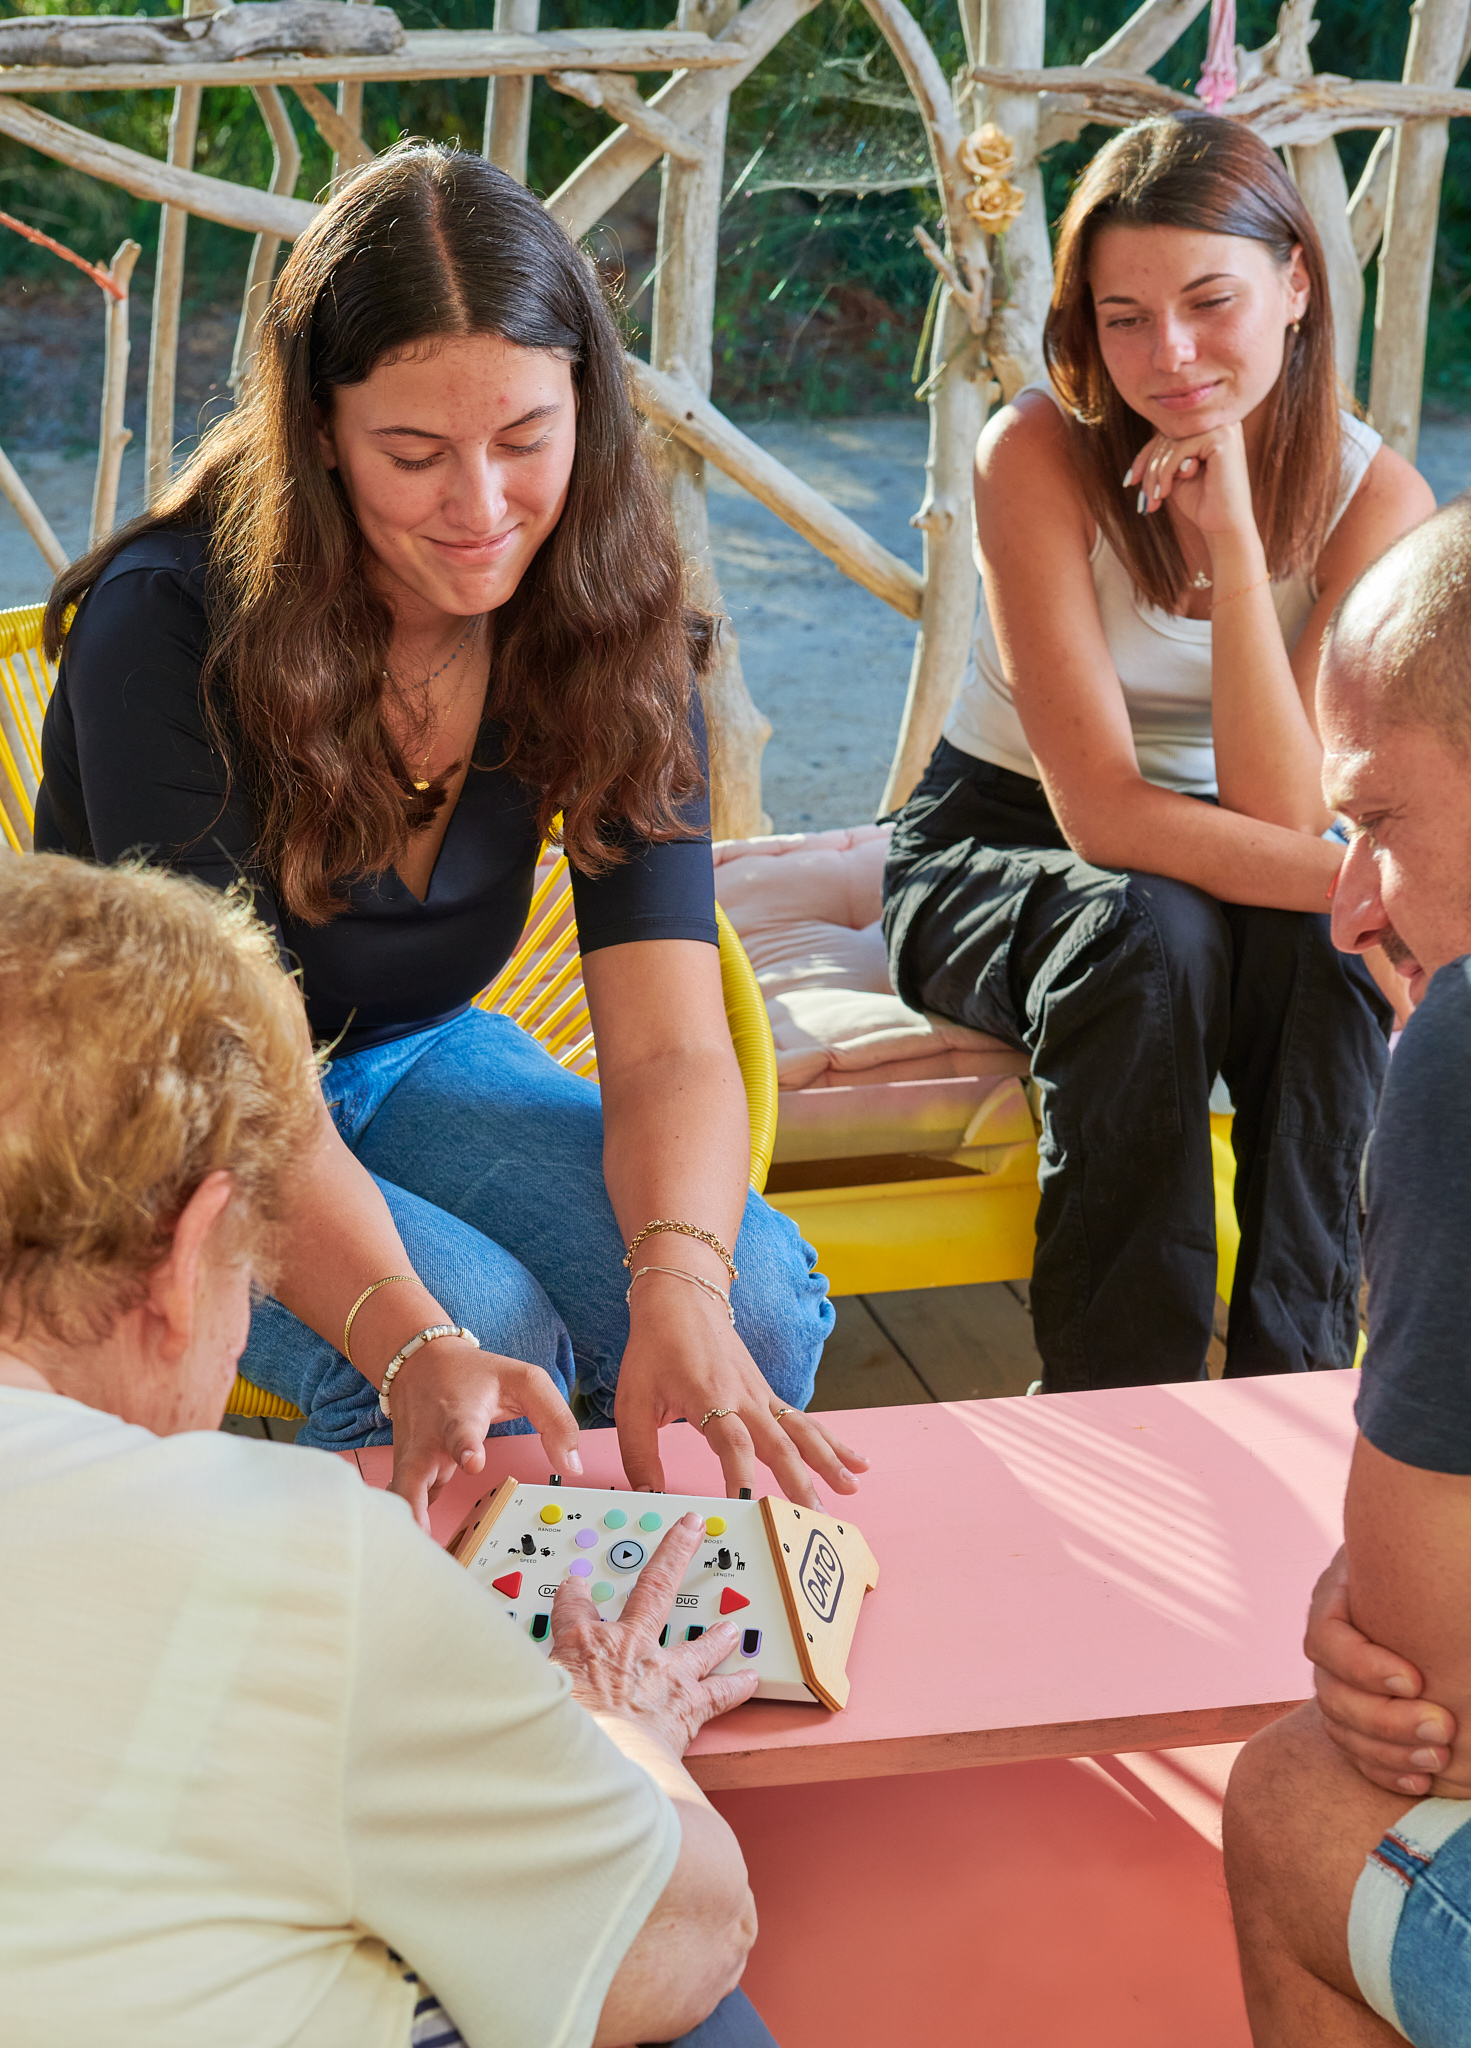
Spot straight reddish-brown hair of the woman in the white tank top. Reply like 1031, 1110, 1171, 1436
1043, 115, 1344, 612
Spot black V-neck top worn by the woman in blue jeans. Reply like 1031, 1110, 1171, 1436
35, 532, 719, 1055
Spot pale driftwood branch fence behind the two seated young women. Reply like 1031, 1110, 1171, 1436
0, 0, 1471, 815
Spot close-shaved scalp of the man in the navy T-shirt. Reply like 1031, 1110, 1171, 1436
1323, 492, 1471, 758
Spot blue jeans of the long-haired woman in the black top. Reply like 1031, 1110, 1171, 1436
240, 1010, 834, 1450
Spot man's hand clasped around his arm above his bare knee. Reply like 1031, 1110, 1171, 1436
1303, 1550, 1457, 1798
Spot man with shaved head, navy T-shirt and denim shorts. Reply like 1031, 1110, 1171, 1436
1225, 500, 1471, 2048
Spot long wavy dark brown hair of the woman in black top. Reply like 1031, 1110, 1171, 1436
45, 143, 713, 924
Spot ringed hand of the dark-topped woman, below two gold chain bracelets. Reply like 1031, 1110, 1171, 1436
613, 1276, 869, 1511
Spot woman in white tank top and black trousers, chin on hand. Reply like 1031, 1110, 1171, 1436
885, 115, 1432, 1393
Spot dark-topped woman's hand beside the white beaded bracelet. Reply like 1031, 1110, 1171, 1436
389, 1337, 582, 1530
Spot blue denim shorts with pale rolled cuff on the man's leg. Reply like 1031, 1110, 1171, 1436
1348, 1798, 1471, 2048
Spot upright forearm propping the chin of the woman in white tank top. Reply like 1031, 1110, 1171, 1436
1211, 532, 1328, 836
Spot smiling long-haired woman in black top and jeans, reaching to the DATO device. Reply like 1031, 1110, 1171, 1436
37, 145, 863, 1518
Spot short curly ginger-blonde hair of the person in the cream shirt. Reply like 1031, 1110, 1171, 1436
0, 854, 322, 1343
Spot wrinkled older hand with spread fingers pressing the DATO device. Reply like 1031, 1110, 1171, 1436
551, 1513, 756, 1757
